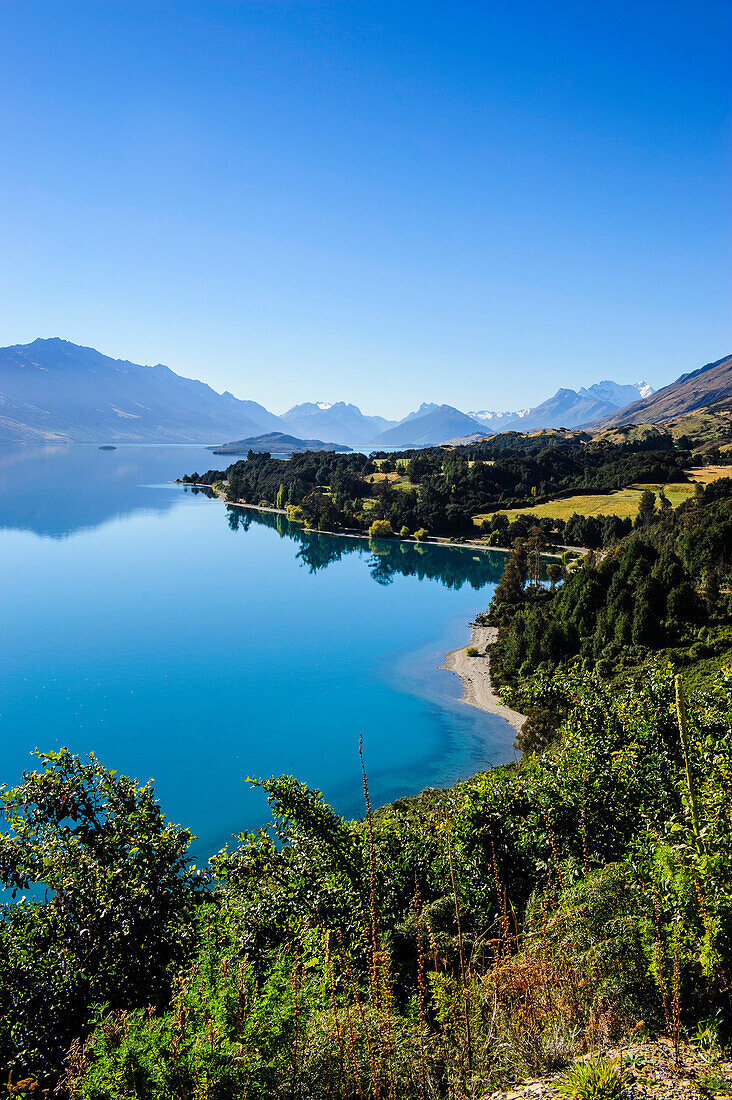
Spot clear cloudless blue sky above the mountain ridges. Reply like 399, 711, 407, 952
0, 0, 732, 416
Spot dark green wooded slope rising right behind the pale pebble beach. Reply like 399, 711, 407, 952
485, 477, 732, 748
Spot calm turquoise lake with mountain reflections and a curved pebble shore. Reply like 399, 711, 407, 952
0, 446, 514, 856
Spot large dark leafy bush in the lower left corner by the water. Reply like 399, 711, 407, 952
0, 749, 203, 1078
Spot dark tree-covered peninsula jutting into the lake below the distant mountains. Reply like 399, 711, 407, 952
183, 432, 690, 536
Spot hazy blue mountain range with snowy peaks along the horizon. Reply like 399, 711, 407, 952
0, 339, 732, 449
